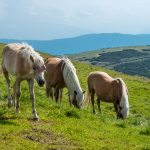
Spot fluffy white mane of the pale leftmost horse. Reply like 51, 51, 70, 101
16, 43, 43, 61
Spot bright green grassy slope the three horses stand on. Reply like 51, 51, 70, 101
0, 45, 150, 150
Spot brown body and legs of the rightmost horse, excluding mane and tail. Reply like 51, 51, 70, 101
87, 72, 122, 117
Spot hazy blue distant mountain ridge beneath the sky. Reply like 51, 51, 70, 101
0, 33, 150, 55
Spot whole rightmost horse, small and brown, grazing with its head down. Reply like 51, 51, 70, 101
85, 71, 129, 119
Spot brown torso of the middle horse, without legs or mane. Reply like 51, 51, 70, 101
44, 58, 63, 86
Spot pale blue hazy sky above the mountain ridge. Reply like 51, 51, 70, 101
0, 0, 150, 40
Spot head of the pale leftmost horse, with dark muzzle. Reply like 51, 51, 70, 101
30, 55, 46, 86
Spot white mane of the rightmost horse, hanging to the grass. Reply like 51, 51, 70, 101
117, 78, 129, 118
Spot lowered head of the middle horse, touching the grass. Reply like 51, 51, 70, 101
70, 91, 84, 108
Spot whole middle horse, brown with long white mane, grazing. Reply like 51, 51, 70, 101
44, 58, 84, 108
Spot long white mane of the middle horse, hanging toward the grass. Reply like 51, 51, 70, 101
62, 57, 84, 106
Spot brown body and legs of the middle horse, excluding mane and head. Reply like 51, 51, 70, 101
44, 58, 65, 101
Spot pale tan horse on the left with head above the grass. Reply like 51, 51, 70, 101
2, 43, 45, 119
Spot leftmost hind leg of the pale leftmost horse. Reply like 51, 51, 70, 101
3, 70, 12, 107
